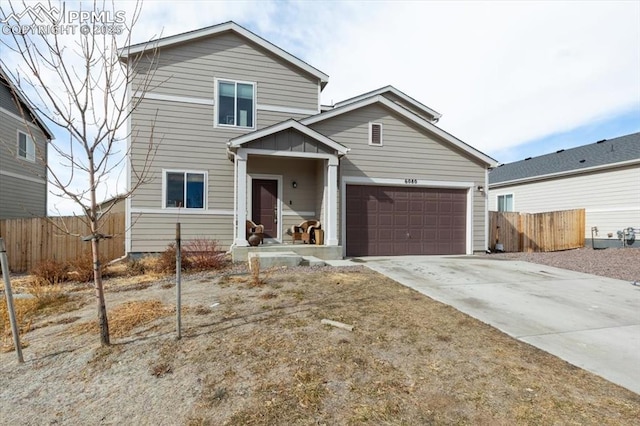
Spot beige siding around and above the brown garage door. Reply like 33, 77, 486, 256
310, 105, 486, 251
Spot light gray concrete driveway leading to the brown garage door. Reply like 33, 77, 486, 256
356, 256, 640, 394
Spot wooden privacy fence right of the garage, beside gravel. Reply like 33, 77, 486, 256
489, 209, 585, 252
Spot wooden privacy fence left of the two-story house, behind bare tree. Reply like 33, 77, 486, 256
0, 213, 125, 272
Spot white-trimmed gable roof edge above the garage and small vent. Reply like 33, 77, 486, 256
300, 94, 497, 167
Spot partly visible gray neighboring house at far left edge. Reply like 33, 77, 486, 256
0, 67, 53, 219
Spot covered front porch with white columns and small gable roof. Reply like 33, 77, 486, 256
228, 120, 347, 255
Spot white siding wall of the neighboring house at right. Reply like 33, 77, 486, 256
489, 164, 640, 238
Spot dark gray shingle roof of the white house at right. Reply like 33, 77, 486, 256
489, 133, 640, 185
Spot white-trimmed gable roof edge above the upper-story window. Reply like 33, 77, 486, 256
118, 21, 329, 88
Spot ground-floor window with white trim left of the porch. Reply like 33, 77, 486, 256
164, 171, 207, 209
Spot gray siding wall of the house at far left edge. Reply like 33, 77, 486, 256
0, 106, 47, 218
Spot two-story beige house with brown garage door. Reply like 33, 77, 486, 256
121, 22, 496, 257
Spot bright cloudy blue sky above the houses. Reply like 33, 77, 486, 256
0, 0, 640, 210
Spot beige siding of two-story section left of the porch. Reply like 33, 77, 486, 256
131, 32, 319, 252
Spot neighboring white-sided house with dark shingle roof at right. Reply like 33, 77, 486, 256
489, 133, 640, 246
